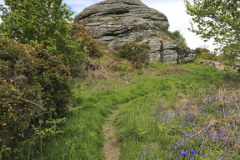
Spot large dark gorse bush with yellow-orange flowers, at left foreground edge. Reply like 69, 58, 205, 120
0, 37, 77, 159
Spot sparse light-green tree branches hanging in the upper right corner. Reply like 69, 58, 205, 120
184, 0, 240, 61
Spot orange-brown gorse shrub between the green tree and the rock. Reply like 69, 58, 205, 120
66, 20, 105, 58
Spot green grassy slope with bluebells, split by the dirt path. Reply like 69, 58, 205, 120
33, 59, 239, 160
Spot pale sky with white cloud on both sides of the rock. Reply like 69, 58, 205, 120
0, 0, 237, 55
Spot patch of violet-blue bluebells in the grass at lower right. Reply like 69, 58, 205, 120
121, 94, 240, 160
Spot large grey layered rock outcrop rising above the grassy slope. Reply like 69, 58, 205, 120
74, 0, 193, 64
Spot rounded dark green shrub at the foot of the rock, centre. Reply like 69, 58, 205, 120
114, 42, 151, 69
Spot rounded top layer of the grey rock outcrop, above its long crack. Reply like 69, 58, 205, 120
75, 0, 169, 26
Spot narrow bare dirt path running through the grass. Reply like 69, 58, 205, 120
103, 110, 120, 160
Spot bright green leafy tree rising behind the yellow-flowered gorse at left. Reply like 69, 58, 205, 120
0, 0, 87, 65
